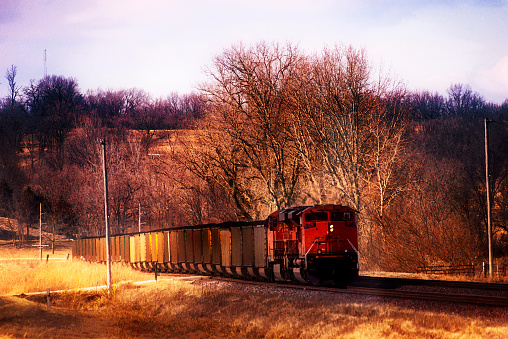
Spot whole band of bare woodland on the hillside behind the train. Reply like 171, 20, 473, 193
0, 42, 508, 270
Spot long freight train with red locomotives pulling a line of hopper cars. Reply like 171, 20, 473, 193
72, 205, 358, 284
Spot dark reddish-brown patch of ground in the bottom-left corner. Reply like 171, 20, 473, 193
0, 296, 120, 338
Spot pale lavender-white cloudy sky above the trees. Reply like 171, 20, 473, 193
0, 0, 508, 104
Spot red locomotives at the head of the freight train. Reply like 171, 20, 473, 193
267, 205, 358, 283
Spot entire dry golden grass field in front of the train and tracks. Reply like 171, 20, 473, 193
0, 245, 508, 338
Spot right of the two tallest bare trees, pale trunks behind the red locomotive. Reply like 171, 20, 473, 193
294, 46, 405, 215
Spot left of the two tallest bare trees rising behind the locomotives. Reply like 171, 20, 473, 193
196, 43, 302, 215
